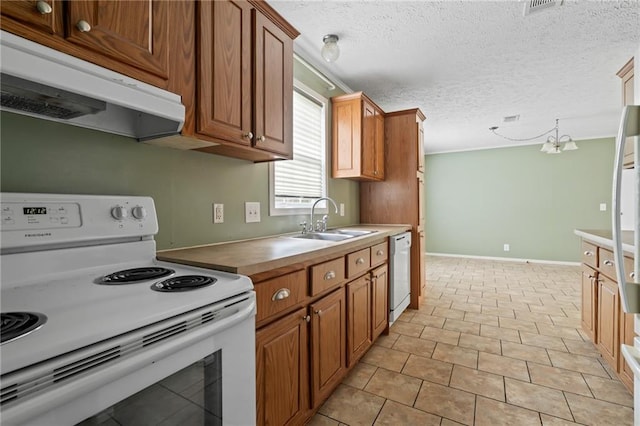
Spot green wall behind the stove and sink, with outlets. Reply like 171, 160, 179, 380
0, 69, 360, 249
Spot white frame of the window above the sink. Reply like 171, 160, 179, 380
269, 79, 330, 216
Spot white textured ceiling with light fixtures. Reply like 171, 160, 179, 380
269, 0, 640, 153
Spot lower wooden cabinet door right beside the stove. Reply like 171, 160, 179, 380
256, 308, 309, 425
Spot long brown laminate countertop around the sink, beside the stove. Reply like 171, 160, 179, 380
157, 225, 418, 275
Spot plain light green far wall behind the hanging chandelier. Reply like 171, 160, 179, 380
425, 138, 614, 262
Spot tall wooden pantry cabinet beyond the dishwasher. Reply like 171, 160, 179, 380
360, 109, 426, 309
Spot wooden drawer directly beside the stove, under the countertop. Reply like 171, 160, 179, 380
255, 270, 307, 322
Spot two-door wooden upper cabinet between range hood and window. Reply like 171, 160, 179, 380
194, 0, 298, 162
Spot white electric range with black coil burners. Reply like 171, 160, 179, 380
0, 193, 256, 425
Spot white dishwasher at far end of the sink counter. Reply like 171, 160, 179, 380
389, 232, 411, 325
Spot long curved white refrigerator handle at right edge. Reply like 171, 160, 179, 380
611, 105, 640, 313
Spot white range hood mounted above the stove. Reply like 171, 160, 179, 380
0, 31, 185, 141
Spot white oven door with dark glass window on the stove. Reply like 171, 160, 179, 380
2, 292, 256, 426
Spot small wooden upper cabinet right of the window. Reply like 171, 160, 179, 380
331, 92, 385, 181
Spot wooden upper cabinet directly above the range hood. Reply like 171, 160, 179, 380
1, 0, 170, 88
